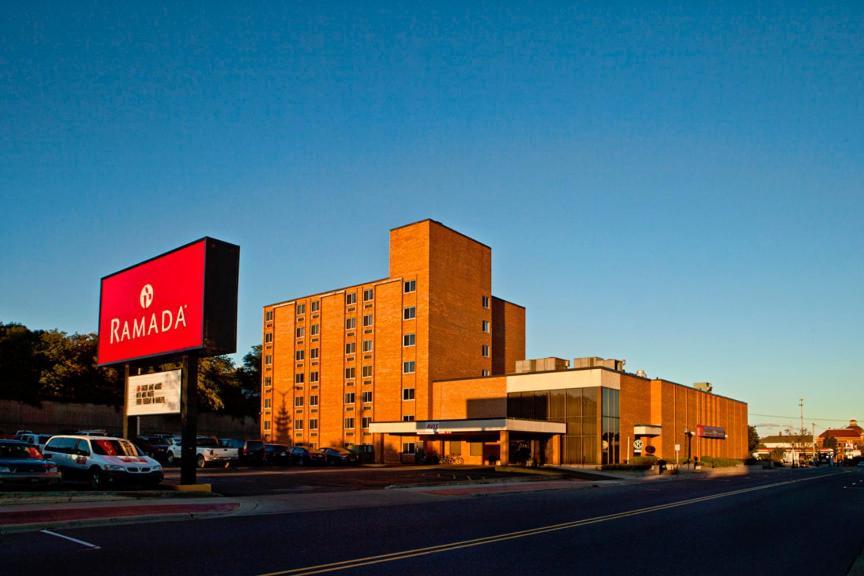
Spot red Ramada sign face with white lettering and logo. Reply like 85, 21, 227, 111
99, 239, 207, 365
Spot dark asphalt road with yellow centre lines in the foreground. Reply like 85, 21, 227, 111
0, 468, 864, 576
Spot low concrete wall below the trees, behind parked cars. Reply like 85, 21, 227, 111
0, 400, 258, 438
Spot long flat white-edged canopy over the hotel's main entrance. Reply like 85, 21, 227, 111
369, 418, 567, 436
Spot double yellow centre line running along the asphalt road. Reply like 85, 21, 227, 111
259, 474, 834, 576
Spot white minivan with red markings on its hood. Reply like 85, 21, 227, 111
44, 435, 163, 490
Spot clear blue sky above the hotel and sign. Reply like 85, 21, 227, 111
0, 2, 864, 434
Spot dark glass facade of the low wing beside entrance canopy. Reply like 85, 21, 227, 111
507, 386, 620, 464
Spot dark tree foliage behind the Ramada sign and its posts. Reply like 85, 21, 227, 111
0, 323, 261, 416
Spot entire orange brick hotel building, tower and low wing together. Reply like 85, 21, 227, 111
261, 220, 747, 464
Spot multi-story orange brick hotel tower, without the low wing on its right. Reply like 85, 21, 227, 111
261, 220, 525, 458
